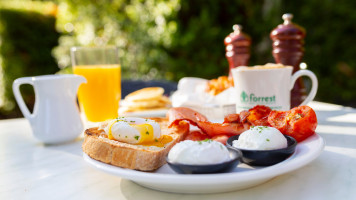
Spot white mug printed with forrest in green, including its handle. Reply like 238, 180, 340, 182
232, 66, 318, 112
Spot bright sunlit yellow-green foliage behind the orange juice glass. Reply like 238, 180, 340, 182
54, 0, 179, 80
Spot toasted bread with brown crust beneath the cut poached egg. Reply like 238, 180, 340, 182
82, 118, 189, 171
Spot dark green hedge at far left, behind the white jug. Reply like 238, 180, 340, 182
0, 4, 59, 117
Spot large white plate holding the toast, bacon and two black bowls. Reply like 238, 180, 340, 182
83, 134, 324, 193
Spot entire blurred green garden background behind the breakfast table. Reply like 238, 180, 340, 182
0, 0, 356, 117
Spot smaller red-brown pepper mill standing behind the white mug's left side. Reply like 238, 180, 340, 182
224, 24, 251, 76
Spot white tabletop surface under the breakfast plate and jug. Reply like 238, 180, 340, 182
0, 102, 356, 200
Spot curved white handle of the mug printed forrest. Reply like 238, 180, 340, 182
290, 69, 318, 106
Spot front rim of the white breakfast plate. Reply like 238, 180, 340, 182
83, 134, 325, 190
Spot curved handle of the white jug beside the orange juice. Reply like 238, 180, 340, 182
12, 77, 36, 120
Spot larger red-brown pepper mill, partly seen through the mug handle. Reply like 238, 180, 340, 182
270, 14, 306, 108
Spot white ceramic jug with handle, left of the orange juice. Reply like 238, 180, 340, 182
12, 74, 86, 144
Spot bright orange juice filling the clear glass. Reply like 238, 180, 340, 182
73, 64, 121, 122
